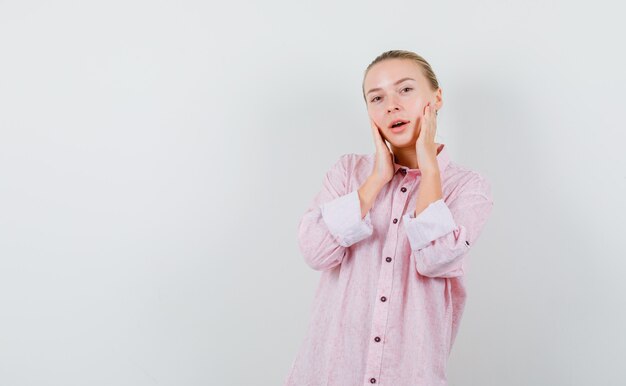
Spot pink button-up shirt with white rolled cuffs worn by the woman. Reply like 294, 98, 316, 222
285, 144, 493, 386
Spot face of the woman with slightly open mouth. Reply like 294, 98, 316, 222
363, 59, 443, 148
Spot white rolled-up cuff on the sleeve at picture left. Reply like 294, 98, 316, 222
320, 190, 374, 247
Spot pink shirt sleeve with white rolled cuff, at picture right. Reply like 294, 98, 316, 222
402, 173, 493, 277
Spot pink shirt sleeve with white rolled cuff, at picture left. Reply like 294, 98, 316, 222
298, 154, 374, 271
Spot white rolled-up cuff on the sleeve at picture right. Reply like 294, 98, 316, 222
402, 199, 457, 250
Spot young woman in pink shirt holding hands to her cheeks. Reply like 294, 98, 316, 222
285, 50, 493, 386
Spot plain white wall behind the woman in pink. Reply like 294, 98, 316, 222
0, 0, 626, 386
